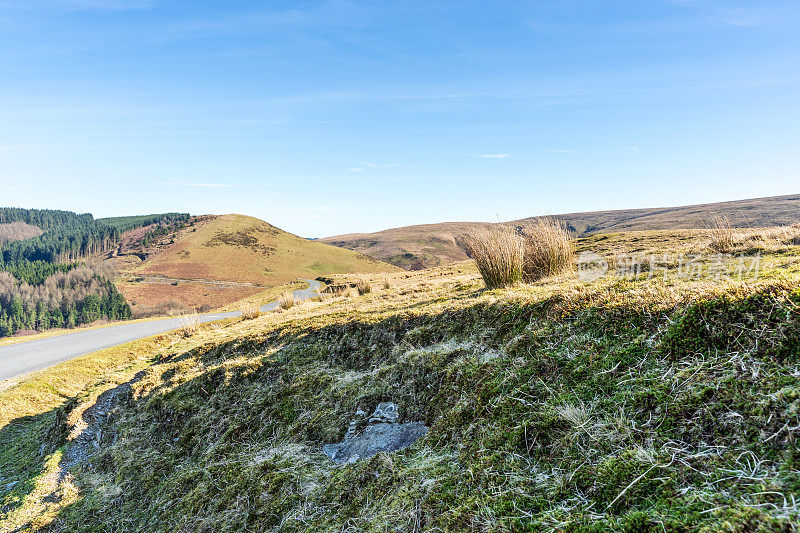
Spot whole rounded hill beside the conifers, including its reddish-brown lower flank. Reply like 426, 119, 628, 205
111, 214, 397, 316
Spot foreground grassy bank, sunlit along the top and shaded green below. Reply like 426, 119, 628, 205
0, 228, 800, 531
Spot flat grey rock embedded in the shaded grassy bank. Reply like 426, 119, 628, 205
322, 402, 428, 464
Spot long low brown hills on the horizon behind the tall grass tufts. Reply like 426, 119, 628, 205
320, 194, 800, 270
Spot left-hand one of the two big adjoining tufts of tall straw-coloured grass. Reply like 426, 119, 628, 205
463, 228, 525, 289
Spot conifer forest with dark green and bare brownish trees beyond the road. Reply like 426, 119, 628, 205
0, 208, 189, 337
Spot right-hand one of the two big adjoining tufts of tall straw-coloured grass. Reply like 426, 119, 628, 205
522, 219, 573, 283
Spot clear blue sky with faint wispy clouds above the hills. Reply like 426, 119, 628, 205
0, 0, 800, 237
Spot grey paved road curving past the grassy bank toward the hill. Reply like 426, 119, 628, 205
0, 279, 321, 382
